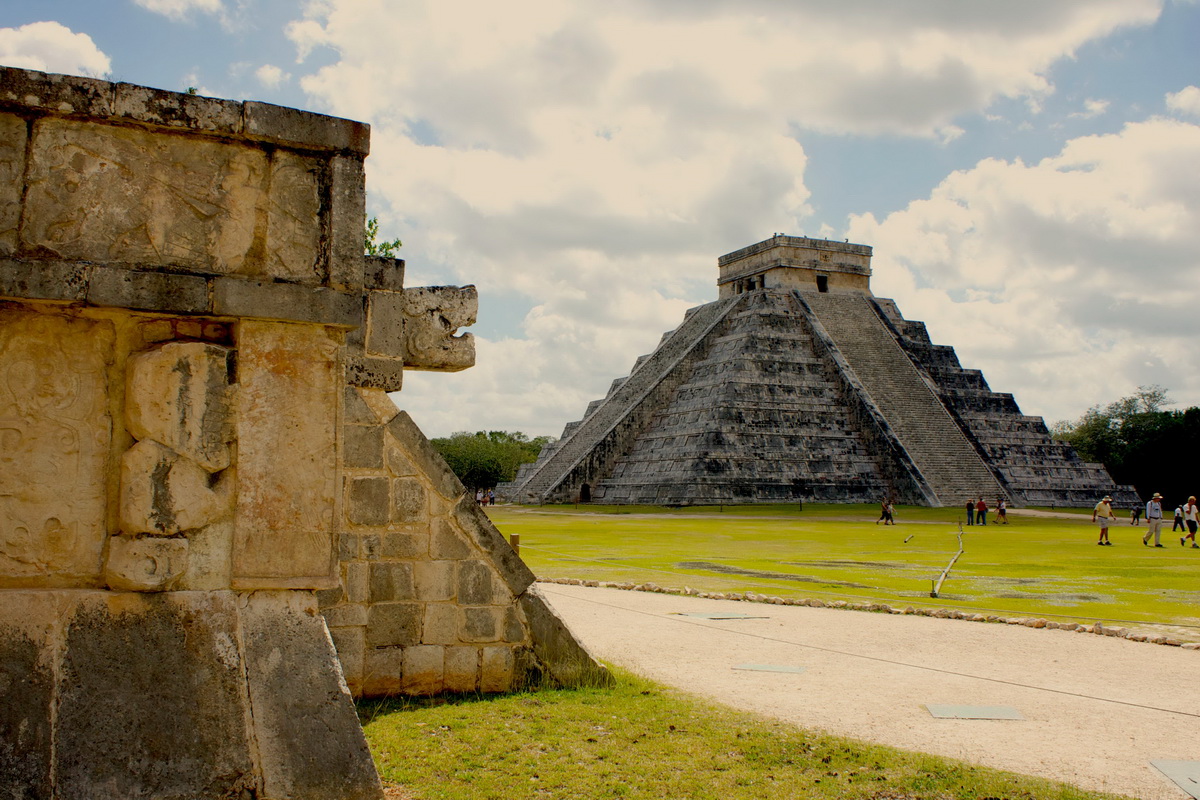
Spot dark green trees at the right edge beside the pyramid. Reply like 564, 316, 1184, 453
1050, 385, 1200, 505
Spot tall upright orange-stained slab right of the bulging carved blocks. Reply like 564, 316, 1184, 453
234, 320, 342, 589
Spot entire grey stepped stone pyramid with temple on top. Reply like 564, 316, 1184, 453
498, 235, 1138, 506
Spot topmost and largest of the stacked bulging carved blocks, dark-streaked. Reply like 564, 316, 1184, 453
125, 342, 233, 473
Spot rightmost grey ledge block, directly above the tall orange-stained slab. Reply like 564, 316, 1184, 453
212, 277, 362, 327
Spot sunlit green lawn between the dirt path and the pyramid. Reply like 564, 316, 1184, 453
488, 505, 1200, 639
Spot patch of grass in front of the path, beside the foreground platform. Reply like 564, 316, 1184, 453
359, 673, 1116, 800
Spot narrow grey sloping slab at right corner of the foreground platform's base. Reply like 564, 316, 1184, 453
237, 591, 383, 800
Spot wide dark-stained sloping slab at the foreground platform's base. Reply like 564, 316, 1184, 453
55, 593, 258, 800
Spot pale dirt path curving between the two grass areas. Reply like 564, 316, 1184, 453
549, 584, 1200, 800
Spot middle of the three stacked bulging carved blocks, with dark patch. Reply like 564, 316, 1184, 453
121, 439, 234, 536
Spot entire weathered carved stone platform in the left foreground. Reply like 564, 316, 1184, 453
0, 68, 606, 800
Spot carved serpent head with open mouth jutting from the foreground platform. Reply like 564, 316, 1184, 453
403, 287, 479, 372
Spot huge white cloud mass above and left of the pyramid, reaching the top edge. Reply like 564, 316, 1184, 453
287, 0, 1162, 434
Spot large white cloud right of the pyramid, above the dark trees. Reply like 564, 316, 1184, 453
850, 119, 1200, 421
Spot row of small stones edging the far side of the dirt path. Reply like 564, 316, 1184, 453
538, 578, 1200, 650
